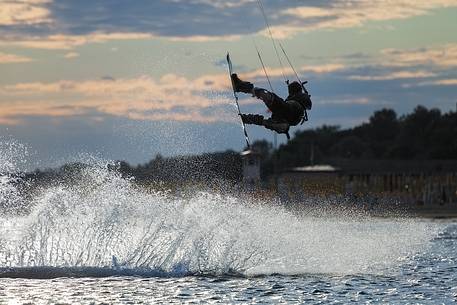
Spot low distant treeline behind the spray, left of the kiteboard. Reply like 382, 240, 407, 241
22, 150, 242, 188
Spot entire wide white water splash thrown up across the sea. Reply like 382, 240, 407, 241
0, 141, 438, 276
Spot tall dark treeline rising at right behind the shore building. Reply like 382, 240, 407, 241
254, 106, 457, 175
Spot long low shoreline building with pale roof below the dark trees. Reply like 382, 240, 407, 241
277, 159, 457, 207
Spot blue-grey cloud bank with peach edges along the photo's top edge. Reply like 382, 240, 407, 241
0, 0, 457, 44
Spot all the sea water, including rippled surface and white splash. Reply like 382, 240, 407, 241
0, 140, 457, 304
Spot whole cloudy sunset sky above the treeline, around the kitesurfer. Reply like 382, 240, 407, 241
0, 0, 457, 169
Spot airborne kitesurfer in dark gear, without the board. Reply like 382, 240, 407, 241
231, 73, 312, 135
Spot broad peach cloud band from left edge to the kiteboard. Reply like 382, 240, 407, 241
0, 74, 235, 122
